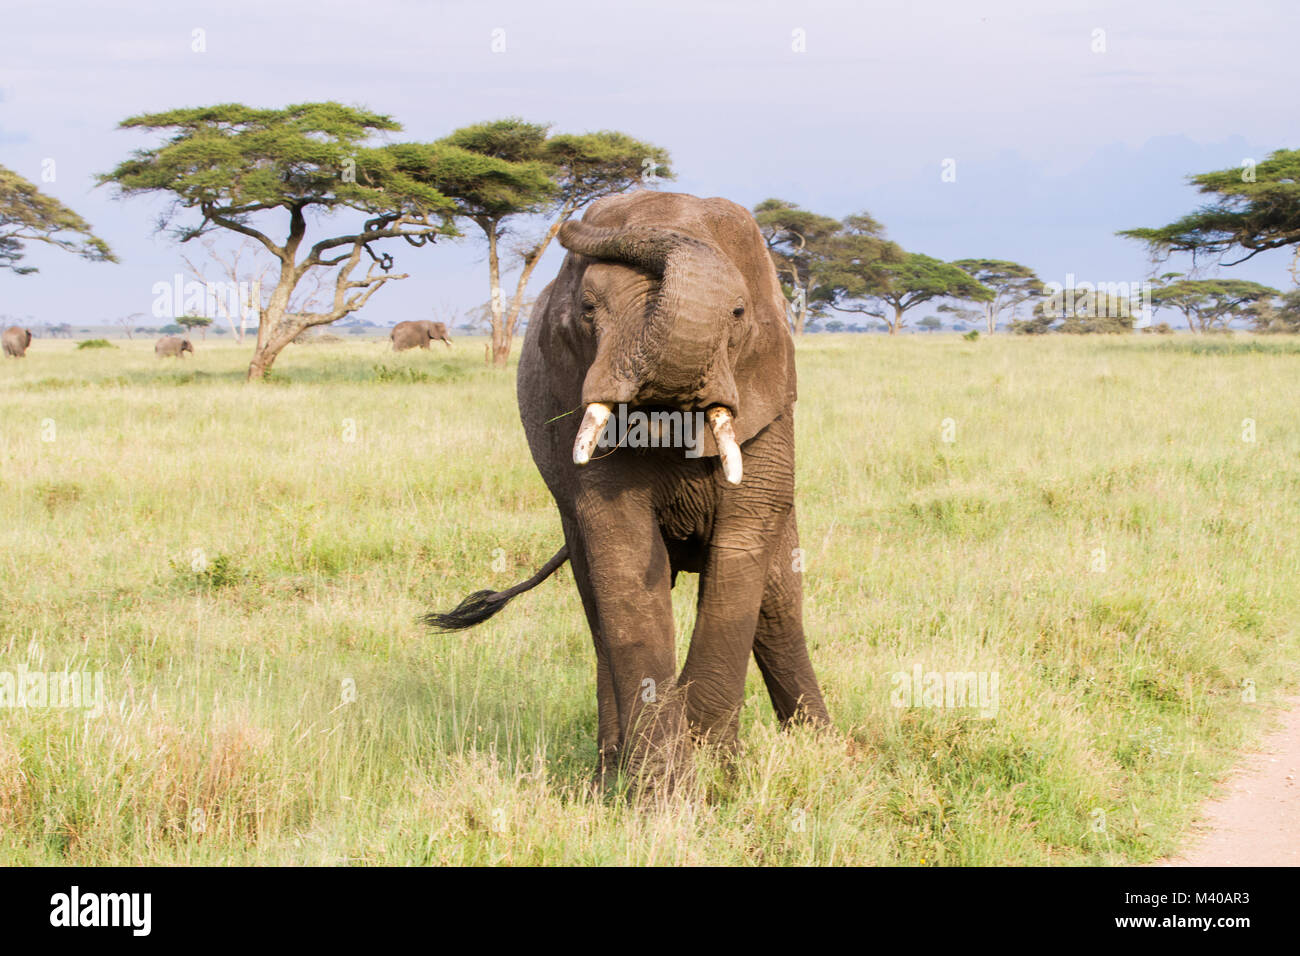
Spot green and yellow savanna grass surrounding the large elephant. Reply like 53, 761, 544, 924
0, 336, 1300, 865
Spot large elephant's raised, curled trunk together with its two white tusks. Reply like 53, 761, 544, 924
560, 222, 745, 484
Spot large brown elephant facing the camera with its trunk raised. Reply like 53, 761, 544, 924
425, 191, 829, 786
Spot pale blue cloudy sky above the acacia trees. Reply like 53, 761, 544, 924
0, 0, 1300, 325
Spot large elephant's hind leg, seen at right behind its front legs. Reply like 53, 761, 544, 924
754, 511, 831, 727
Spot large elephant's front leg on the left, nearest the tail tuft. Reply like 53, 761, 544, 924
579, 502, 685, 786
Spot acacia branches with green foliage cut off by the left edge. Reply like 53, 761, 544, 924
0, 166, 117, 276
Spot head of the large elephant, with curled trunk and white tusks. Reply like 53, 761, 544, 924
559, 194, 794, 484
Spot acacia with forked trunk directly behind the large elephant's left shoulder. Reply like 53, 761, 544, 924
439, 117, 673, 368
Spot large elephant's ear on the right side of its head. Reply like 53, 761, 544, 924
706, 199, 797, 454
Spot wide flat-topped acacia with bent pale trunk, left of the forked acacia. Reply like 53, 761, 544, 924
99, 103, 467, 381
